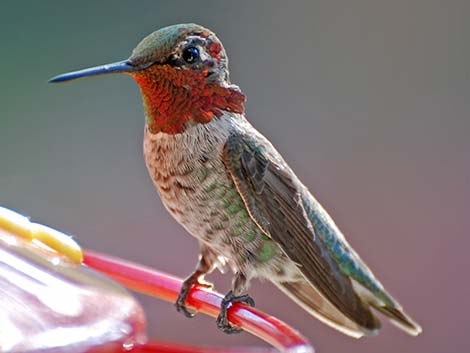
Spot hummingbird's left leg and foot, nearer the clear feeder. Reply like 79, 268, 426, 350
175, 246, 216, 318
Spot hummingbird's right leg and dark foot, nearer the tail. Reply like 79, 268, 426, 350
216, 273, 255, 334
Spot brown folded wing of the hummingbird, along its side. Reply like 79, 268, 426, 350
223, 131, 380, 330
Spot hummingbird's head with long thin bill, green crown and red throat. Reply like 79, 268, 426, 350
49, 24, 245, 134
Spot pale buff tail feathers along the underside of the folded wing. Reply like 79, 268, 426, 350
274, 281, 380, 338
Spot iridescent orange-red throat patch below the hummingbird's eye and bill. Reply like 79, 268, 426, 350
132, 65, 245, 134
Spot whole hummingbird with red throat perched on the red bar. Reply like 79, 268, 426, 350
50, 24, 422, 338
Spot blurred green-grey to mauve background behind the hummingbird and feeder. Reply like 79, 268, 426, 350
0, 0, 470, 353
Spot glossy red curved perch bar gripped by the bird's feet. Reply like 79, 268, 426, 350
83, 250, 314, 353
